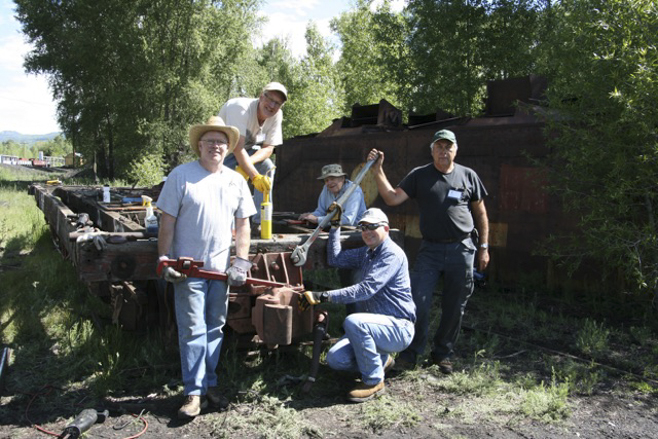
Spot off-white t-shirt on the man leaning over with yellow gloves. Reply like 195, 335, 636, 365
219, 98, 283, 149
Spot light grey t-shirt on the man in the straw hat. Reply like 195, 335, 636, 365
157, 160, 256, 272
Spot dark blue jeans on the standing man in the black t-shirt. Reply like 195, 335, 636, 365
400, 238, 476, 363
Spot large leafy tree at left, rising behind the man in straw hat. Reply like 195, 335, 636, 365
16, 0, 259, 178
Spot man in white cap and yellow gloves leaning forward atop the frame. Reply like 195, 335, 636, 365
219, 82, 288, 229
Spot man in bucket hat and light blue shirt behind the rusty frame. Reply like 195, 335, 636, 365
299, 163, 366, 226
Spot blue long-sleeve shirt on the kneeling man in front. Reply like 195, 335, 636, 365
327, 228, 416, 322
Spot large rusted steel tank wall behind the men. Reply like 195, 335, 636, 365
274, 102, 561, 286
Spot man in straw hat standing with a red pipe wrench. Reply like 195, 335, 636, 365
158, 116, 256, 419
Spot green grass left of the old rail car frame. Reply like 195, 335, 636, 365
0, 169, 178, 402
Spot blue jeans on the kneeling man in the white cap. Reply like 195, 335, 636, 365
327, 313, 414, 386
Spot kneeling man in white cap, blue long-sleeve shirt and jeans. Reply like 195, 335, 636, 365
299, 207, 416, 402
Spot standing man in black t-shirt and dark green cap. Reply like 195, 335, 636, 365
368, 130, 489, 374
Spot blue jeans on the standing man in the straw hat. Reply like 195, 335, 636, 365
174, 278, 228, 395
